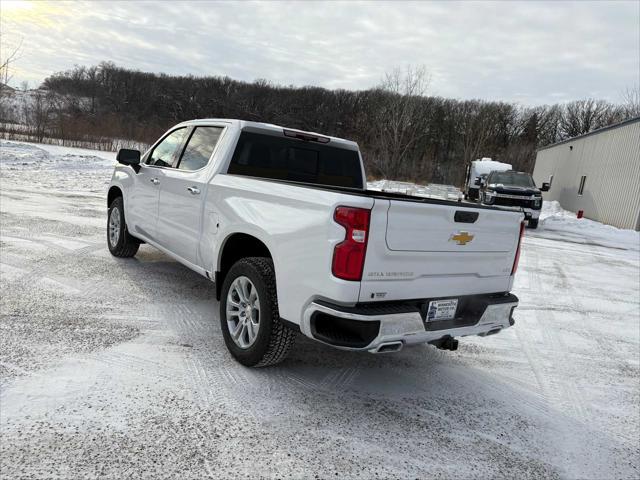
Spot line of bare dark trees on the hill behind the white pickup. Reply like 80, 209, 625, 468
0, 63, 640, 185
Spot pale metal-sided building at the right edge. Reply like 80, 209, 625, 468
533, 117, 640, 230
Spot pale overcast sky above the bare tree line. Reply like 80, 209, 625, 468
0, 0, 640, 105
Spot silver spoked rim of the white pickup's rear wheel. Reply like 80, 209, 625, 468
227, 276, 260, 348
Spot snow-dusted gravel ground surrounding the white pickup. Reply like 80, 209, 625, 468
0, 142, 640, 479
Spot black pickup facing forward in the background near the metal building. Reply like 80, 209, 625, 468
480, 170, 550, 228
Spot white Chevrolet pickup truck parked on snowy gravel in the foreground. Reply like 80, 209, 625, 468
107, 119, 524, 366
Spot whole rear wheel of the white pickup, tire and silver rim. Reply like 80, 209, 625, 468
220, 257, 295, 367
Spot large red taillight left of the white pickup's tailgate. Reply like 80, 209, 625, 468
331, 207, 371, 281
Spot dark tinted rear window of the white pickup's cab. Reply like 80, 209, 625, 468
228, 132, 363, 189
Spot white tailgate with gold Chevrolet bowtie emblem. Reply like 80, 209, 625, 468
360, 199, 523, 302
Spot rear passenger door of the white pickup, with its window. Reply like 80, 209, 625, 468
158, 126, 223, 265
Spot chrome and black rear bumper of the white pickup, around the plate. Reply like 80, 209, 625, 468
300, 293, 518, 352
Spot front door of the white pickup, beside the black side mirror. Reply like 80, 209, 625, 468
127, 127, 187, 241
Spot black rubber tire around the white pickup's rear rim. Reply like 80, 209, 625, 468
220, 257, 296, 367
